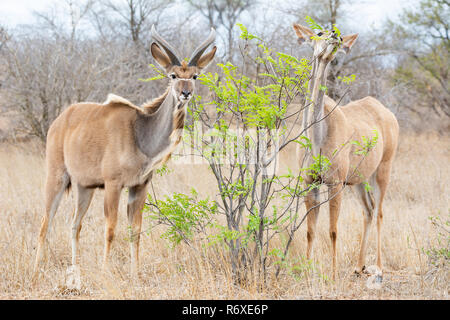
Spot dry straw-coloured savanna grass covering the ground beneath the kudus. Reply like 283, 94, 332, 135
0, 133, 450, 299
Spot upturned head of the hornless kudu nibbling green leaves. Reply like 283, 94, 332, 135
294, 23, 358, 63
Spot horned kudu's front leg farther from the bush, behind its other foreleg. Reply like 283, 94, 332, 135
103, 183, 122, 270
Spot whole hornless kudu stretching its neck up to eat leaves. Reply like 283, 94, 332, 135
294, 24, 399, 279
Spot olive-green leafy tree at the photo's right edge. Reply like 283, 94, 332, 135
387, 0, 450, 118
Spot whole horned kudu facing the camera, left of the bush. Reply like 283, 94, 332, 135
34, 27, 217, 275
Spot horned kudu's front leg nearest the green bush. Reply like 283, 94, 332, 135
127, 183, 147, 278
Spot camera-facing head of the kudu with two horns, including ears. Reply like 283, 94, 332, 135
151, 26, 217, 105
